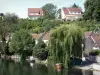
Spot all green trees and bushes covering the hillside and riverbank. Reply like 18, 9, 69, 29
0, 0, 100, 67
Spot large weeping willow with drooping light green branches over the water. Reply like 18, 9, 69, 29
49, 24, 83, 67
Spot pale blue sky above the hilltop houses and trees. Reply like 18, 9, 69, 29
0, 0, 85, 18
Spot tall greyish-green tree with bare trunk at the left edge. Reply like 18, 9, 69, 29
0, 13, 18, 55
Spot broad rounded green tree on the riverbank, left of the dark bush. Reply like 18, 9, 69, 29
10, 29, 35, 59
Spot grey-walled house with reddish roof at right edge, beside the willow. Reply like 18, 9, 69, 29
84, 31, 100, 54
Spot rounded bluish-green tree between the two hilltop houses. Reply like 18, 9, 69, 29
42, 3, 57, 19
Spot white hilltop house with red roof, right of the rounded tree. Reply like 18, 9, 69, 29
61, 7, 82, 21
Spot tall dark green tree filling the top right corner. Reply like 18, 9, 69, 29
83, 0, 100, 21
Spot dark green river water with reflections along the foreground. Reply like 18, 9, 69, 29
0, 60, 100, 75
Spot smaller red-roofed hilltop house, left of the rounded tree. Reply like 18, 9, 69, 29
28, 8, 43, 19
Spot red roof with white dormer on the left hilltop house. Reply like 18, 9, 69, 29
28, 8, 43, 16
